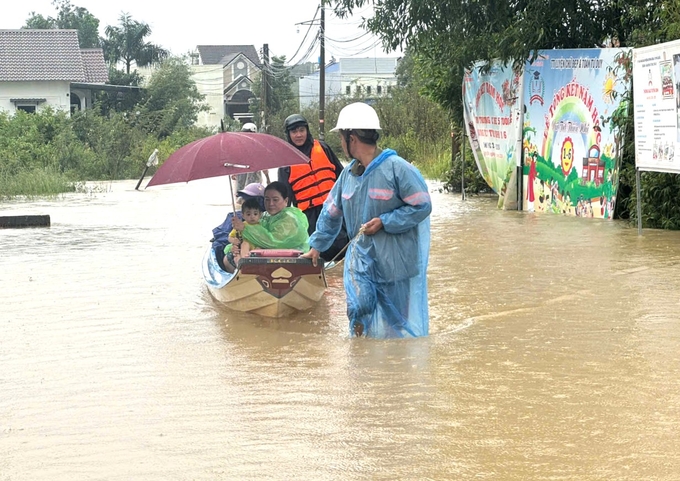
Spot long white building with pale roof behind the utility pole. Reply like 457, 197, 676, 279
299, 57, 400, 109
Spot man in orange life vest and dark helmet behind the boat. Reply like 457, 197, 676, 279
278, 114, 349, 261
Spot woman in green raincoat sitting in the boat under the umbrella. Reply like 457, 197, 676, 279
231, 181, 309, 272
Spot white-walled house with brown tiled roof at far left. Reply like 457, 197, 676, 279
0, 29, 109, 113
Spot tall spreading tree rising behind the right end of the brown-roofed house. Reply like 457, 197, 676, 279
102, 13, 169, 74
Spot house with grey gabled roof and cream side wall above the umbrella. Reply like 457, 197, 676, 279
191, 45, 262, 127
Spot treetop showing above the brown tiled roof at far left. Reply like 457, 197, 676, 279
24, 0, 99, 48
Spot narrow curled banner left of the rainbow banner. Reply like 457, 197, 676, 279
463, 63, 522, 205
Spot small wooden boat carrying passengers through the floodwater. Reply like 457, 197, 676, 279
203, 248, 328, 317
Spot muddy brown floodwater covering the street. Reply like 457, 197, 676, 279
0, 178, 680, 481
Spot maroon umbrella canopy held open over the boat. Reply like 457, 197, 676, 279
147, 132, 309, 187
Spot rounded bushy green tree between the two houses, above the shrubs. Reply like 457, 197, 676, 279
130, 57, 208, 139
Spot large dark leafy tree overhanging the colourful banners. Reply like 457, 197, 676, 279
331, 0, 652, 122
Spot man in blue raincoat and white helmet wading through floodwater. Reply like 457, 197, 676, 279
303, 102, 432, 338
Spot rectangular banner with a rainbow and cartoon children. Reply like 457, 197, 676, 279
522, 49, 627, 219
